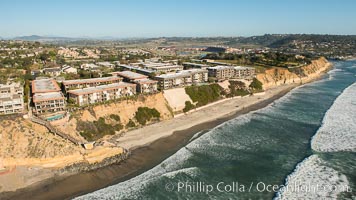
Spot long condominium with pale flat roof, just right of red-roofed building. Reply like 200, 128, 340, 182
67, 82, 136, 106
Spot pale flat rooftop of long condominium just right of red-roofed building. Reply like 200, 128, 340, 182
68, 82, 136, 95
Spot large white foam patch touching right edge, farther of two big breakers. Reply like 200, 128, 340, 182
311, 83, 356, 152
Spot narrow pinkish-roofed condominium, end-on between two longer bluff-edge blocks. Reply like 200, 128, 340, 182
112, 71, 157, 93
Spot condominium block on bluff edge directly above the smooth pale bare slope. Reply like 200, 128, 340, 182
155, 69, 208, 90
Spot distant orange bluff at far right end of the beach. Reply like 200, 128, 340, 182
257, 57, 331, 90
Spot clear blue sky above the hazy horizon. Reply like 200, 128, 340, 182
0, 0, 356, 38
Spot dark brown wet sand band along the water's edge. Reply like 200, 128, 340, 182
0, 86, 294, 200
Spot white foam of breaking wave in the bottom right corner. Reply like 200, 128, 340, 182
275, 155, 351, 200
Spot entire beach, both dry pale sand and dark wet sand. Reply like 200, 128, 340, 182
0, 62, 330, 199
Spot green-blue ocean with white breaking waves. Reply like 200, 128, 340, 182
77, 61, 356, 199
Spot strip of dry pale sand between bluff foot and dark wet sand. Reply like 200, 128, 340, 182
110, 84, 296, 150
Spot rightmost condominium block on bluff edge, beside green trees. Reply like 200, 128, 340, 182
208, 66, 256, 80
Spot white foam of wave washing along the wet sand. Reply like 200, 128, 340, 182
76, 110, 251, 200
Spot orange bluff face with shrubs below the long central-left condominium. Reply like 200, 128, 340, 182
61, 93, 173, 138
